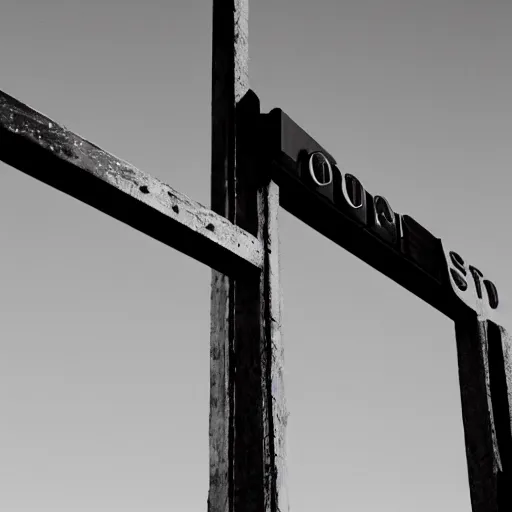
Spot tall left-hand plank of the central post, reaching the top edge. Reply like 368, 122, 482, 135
208, 0, 248, 512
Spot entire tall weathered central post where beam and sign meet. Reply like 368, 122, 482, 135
208, 0, 288, 512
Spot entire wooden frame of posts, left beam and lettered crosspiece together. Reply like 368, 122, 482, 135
0, 0, 512, 512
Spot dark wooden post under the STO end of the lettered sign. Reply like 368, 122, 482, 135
455, 308, 512, 512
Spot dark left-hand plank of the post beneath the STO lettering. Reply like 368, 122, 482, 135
455, 308, 503, 512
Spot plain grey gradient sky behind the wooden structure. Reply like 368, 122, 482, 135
0, 0, 512, 512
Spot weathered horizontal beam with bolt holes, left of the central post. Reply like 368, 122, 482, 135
0, 91, 263, 276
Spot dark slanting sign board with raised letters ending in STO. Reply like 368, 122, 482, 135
260, 109, 502, 325
